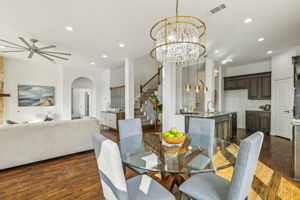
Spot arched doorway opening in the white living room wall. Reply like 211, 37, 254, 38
71, 77, 94, 119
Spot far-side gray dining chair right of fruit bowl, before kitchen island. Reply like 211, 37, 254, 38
187, 118, 215, 169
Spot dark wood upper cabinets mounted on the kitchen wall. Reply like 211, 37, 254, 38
224, 72, 271, 100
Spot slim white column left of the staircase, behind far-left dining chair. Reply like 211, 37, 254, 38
125, 58, 134, 119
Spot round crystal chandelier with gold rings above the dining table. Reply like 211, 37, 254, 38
150, 0, 206, 63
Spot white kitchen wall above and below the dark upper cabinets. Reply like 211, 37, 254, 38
222, 60, 272, 128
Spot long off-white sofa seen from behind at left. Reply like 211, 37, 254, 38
0, 118, 100, 169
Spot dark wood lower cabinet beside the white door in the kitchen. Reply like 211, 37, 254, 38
246, 111, 271, 134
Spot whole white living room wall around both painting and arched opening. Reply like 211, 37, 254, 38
4, 58, 110, 122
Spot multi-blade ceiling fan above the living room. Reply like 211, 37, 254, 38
0, 37, 71, 63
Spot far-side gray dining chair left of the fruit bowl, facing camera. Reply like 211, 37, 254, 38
118, 118, 147, 174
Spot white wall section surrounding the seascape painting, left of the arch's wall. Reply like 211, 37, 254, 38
4, 58, 62, 122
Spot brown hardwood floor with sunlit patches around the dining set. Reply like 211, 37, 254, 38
0, 130, 300, 200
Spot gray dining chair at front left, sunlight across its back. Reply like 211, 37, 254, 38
92, 133, 175, 200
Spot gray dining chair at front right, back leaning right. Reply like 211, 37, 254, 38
179, 132, 264, 200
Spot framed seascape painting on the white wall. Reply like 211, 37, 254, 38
18, 85, 55, 107
